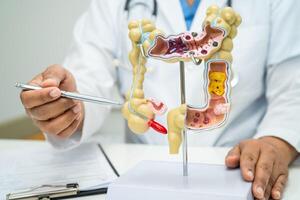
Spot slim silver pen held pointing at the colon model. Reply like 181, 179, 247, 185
15, 83, 123, 106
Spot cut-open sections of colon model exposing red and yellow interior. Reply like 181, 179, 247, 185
147, 25, 230, 130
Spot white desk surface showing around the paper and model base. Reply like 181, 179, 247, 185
0, 140, 300, 200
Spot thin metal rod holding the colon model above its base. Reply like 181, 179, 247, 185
179, 61, 188, 176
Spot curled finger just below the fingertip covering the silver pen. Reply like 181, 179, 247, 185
29, 98, 79, 121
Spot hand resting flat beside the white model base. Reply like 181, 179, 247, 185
225, 136, 298, 200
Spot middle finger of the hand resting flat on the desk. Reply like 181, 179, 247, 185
253, 149, 275, 199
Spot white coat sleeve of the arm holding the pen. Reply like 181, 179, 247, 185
46, 0, 117, 149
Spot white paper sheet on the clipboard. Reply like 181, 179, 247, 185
0, 144, 116, 200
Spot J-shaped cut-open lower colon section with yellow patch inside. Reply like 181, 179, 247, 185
186, 60, 230, 130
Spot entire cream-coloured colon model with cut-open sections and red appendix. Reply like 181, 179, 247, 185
122, 5, 241, 154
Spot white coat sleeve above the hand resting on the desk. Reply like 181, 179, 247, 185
255, 0, 300, 152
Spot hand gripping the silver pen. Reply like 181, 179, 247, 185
20, 65, 84, 138
